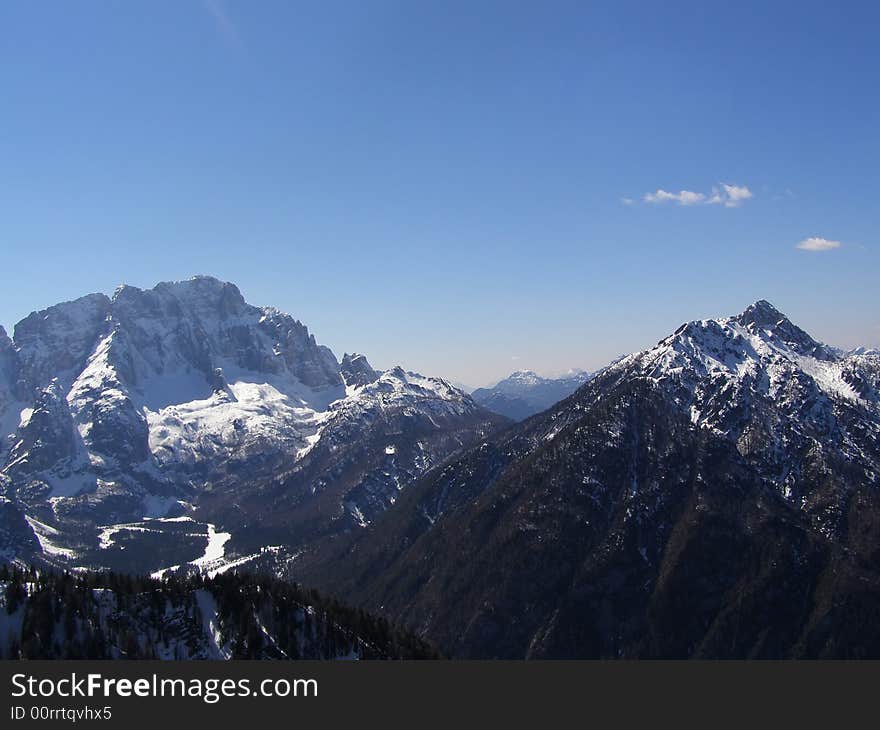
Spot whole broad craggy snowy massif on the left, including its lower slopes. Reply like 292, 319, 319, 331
0, 276, 500, 571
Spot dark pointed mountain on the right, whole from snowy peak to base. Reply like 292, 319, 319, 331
292, 301, 880, 658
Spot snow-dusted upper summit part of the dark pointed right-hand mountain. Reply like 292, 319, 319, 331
604, 301, 880, 498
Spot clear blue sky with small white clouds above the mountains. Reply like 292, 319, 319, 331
0, 0, 880, 385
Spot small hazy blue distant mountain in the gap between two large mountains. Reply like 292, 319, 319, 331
471, 370, 592, 421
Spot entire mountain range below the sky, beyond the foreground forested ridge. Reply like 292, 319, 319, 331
0, 288, 880, 658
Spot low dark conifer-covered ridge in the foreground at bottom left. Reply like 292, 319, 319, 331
0, 565, 438, 659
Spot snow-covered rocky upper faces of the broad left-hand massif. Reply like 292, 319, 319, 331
0, 276, 506, 568
